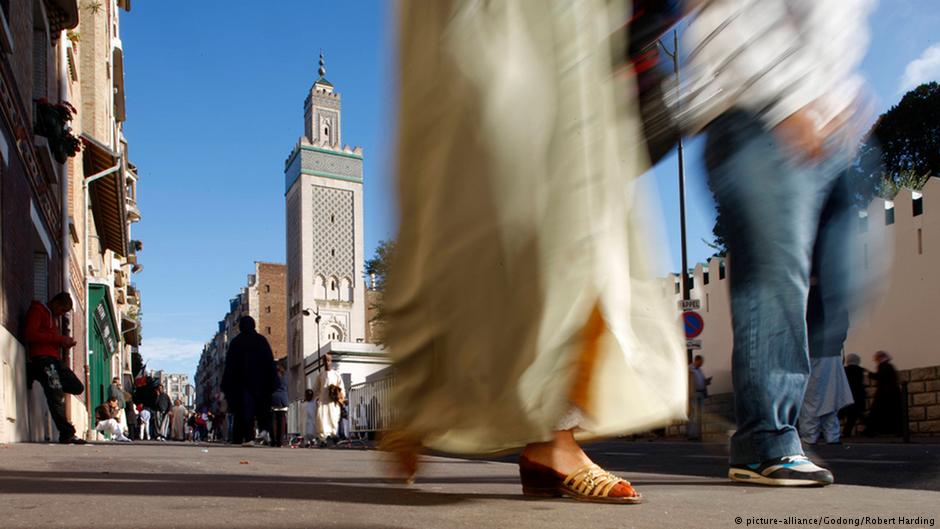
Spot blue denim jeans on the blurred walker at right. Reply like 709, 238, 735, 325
705, 111, 855, 465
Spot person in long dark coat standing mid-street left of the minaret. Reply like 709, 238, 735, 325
221, 316, 277, 444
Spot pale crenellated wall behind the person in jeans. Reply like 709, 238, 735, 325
676, 178, 940, 394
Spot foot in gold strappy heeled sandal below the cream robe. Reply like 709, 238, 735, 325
519, 430, 642, 503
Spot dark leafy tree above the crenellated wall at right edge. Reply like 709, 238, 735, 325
856, 82, 940, 199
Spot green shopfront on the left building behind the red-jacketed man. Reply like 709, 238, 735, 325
87, 284, 118, 426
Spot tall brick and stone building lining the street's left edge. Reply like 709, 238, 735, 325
0, 0, 140, 442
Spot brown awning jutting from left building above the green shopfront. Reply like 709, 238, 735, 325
82, 134, 127, 257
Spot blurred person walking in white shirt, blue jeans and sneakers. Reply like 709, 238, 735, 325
679, 0, 872, 486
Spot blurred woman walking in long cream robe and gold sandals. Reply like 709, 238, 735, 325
385, 0, 687, 503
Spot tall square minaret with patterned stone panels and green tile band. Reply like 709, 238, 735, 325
284, 55, 366, 399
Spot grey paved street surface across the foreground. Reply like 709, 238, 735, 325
0, 443, 940, 529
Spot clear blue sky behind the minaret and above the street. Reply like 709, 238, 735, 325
121, 0, 940, 380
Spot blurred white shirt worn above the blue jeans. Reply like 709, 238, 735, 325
673, 0, 874, 132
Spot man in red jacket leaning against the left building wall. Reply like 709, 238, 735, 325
24, 292, 85, 444
